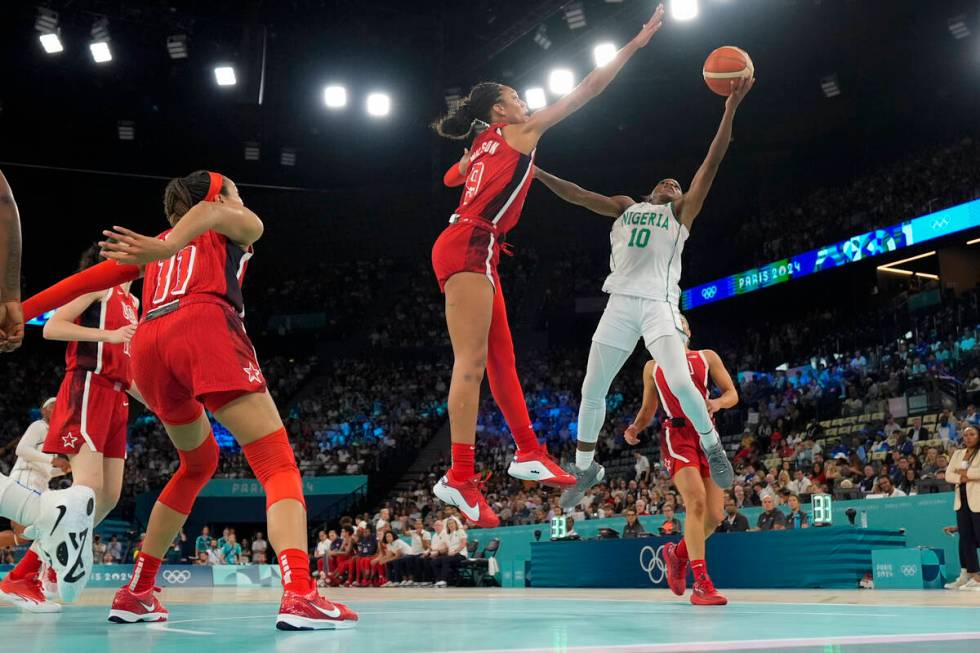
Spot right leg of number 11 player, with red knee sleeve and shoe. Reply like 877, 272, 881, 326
209, 391, 357, 630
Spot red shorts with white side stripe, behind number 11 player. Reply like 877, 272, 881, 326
44, 370, 129, 458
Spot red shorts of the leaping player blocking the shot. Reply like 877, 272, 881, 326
432, 218, 500, 292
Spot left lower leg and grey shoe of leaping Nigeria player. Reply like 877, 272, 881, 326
559, 340, 636, 512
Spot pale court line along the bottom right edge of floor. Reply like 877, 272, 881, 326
448, 632, 980, 653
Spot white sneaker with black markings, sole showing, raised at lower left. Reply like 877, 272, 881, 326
24, 485, 95, 603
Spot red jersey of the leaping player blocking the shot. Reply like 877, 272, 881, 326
456, 123, 534, 234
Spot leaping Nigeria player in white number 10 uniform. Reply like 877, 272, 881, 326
535, 74, 755, 511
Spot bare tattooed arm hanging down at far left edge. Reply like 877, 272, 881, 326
0, 172, 24, 353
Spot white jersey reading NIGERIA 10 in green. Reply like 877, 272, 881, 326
602, 202, 688, 306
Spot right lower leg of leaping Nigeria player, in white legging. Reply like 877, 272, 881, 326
647, 333, 735, 489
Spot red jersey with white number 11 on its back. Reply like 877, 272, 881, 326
143, 230, 252, 316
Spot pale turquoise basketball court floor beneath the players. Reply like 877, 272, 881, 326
0, 588, 980, 653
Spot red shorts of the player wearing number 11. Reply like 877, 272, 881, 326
131, 300, 266, 425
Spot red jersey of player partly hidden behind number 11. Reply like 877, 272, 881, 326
65, 286, 139, 388
